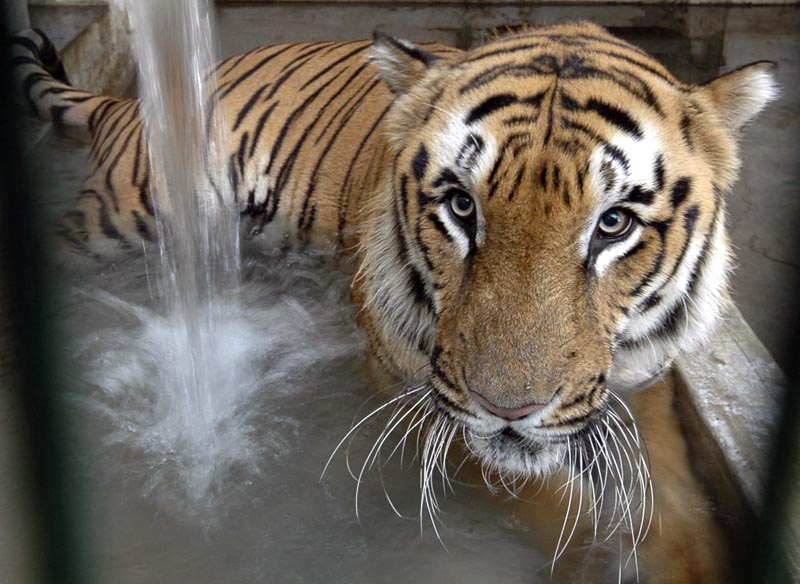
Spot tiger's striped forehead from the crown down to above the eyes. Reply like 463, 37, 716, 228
416, 25, 683, 208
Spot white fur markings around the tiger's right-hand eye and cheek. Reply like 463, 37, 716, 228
579, 125, 730, 390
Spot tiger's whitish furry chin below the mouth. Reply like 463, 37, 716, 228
466, 427, 567, 480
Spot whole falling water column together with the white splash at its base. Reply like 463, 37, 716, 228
72, 0, 260, 501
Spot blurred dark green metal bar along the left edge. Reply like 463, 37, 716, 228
0, 8, 93, 584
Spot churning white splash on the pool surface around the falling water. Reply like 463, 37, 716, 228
66, 253, 363, 515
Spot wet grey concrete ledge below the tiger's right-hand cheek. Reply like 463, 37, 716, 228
674, 306, 800, 581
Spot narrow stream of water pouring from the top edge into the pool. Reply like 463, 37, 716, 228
118, 0, 244, 502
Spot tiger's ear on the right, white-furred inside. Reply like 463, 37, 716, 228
697, 61, 780, 135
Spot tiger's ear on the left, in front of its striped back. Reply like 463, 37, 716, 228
369, 30, 441, 95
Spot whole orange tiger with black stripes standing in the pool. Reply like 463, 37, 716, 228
14, 22, 779, 582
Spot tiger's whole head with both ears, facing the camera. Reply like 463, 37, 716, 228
360, 23, 777, 476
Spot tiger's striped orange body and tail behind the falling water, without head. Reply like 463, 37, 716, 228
10, 33, 456, 256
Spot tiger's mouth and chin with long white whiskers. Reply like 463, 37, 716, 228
322, 374, 652, 538
